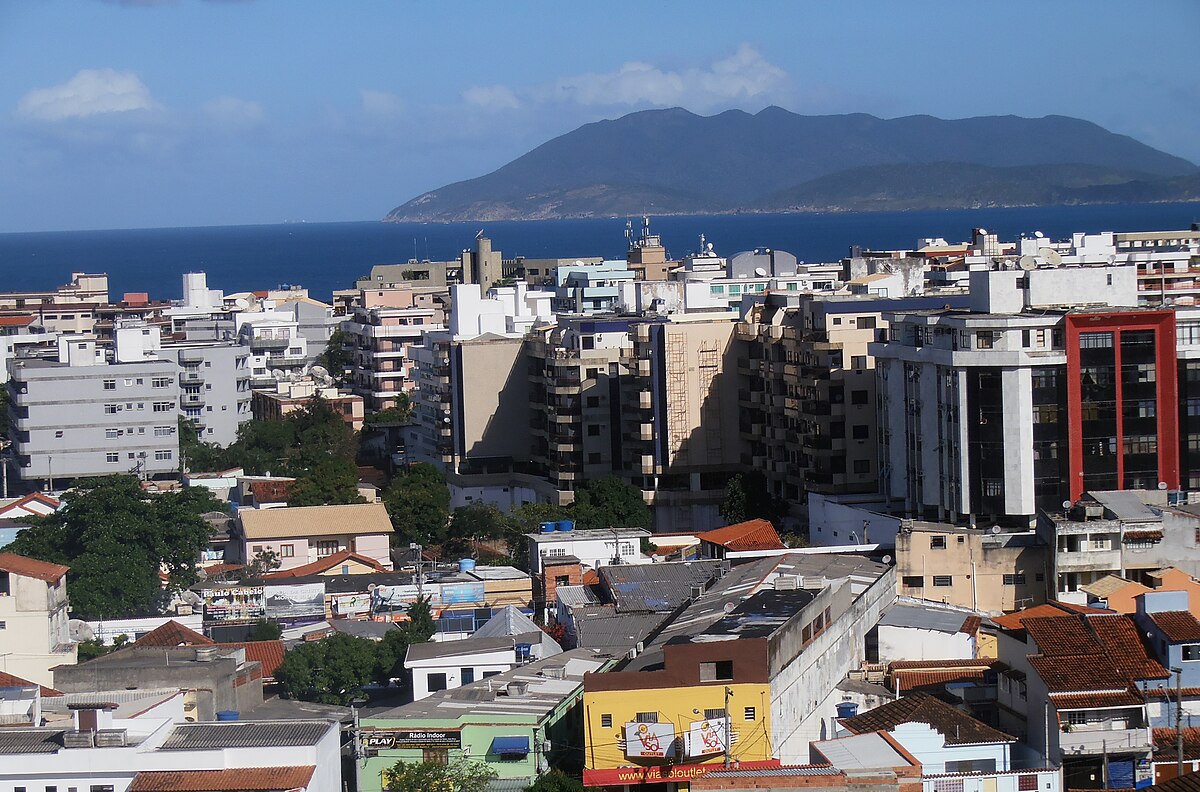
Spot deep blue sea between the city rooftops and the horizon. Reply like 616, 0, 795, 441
0, 203, 1200, 300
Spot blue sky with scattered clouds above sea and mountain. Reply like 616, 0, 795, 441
0, 0, 1200, 233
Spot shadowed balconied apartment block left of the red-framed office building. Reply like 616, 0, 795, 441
736, 293, 966, 503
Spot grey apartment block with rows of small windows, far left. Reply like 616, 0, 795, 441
8, 338, 179, 490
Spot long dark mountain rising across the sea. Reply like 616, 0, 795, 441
385, 107, 1198, 222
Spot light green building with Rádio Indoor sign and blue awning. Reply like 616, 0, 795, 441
358, 649, 618, 792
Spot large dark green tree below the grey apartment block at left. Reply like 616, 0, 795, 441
7, 475, 221, 619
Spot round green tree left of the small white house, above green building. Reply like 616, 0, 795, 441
275, 634, 376, 707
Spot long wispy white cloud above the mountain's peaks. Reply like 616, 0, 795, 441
546, 44, 787, 107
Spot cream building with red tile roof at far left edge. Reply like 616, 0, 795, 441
0, 553, 76, 688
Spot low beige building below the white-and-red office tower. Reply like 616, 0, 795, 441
895, 520, 1054, 616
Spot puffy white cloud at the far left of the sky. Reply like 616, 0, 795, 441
17, 68, 155, 121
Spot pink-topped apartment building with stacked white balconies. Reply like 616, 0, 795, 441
342, 288, 443, 410
